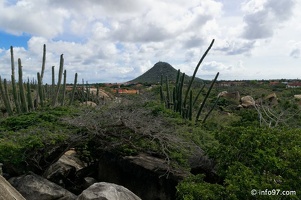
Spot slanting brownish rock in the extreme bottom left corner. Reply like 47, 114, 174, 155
0, 175, 26, 200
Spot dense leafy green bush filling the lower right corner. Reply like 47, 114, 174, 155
178, 126, 301, 199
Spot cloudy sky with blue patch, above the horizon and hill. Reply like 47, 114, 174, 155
0, 0, 301, 83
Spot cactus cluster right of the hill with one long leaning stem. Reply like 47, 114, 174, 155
160, 39, 219, 122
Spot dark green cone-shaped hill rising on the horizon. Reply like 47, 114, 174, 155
129, 61, 200, 83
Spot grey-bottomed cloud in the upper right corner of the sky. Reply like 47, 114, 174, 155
242, 0, 295, 40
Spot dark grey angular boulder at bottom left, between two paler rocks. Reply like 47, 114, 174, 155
9, 173, 76, 200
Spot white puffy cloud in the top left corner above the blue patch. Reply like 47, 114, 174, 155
0, 0, 69, 37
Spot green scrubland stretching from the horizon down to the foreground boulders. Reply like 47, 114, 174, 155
0, 41, 301, 200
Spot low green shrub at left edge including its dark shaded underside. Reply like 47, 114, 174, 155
0, 107, 77, 174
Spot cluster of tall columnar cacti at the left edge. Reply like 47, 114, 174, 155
0, 45, 77, 115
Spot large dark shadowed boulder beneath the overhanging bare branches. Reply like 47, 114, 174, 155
97, 153, 187, 200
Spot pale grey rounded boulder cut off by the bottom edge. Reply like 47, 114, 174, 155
77, 182, 141, 200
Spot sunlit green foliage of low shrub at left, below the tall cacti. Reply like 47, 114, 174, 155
0, 107, 75, 171
